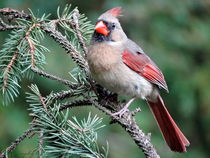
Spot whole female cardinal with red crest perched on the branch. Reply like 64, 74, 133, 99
87, 7, 190, 152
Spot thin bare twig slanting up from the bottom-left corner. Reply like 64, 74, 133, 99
0, 125, 33, 158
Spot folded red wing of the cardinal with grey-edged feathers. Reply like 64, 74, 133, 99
122, 50, 168, 92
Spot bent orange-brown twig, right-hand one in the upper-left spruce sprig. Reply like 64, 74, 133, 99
25, 24, 40, 68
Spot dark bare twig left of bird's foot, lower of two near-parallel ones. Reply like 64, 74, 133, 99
60, 100, 92, 111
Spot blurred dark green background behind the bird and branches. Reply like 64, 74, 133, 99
0, 0, 210, 158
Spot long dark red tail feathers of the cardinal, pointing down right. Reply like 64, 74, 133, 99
147, 95, 190, 152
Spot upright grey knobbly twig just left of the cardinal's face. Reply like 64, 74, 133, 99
72, 9, 88, 57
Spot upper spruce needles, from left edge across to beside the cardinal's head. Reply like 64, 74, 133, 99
0, 5, 93, 105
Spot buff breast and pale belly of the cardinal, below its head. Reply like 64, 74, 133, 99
87, 39, 158, 100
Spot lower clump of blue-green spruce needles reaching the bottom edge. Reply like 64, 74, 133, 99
27, 85, 108, 158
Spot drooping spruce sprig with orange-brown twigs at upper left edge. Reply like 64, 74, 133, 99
0, 14, 49, 104
